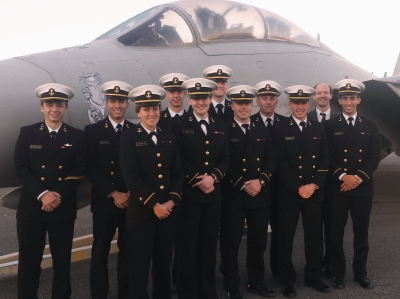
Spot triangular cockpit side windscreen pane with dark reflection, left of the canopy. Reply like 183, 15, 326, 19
118, 8, 193, 47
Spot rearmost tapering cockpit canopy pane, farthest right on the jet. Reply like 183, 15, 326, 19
259, 9, 320, 47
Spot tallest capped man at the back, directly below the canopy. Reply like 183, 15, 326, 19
203, 65, 233, 122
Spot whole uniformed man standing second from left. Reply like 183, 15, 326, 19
85, 81, 136, 299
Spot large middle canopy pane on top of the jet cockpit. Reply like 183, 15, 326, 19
176, 1, 265, 41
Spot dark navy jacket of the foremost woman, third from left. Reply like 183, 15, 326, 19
120, 125, 183, 219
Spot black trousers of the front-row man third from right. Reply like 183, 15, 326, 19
220, 204, 269, 294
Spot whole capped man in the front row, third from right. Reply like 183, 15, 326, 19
221, 85, 276, 299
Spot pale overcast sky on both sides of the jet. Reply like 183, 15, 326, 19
0, 0, 400, 77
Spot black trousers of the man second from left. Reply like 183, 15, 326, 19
90, 212, 129, 299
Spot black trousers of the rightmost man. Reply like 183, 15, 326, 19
331, 195, 372, 278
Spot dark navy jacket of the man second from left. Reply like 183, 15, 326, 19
85, 117, 136, 213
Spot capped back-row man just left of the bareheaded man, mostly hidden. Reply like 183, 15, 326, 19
251, 80, 288, 280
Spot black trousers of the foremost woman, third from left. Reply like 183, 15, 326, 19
127, 211, 178, 299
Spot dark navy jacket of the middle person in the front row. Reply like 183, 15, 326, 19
171, 110, 229, 203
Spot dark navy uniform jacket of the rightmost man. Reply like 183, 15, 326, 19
326, 114, 381, 196
